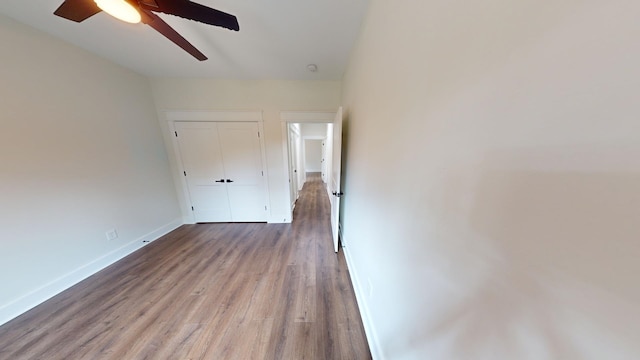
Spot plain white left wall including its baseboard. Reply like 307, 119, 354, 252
0, 16, 180, 324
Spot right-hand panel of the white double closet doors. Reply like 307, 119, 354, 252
218, 123, 267, 222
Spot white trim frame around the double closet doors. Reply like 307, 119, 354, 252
165, 110, 271, 224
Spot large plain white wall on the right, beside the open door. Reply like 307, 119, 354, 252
343, 0, 640, 360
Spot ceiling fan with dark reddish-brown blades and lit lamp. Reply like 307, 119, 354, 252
54, 0, 240, 61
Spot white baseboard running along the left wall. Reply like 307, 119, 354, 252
0, 218, 183, 325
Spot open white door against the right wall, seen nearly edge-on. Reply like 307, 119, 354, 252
329, 107, 343, 252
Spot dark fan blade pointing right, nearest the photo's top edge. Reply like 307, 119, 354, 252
138, 0, 240, 31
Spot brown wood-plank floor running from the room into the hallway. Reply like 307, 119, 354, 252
0, 176, 371, 360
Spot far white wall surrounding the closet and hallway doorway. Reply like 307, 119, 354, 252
151, 78, 341, 222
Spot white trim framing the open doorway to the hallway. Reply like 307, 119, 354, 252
280, 111, 336, 219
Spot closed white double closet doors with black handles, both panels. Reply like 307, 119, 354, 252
175, 122, 267, 222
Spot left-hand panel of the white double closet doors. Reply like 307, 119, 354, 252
175, 122, 232, 222
